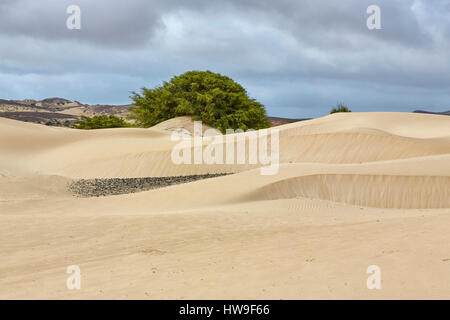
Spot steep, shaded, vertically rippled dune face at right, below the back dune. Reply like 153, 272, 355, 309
250, 174, 450, 209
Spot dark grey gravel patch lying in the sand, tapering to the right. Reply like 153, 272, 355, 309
68, 173, 230, 198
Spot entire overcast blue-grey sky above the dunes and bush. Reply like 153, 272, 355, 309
0, 0, 450, 117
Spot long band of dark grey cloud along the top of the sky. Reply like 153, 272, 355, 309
0, 0, 442, 48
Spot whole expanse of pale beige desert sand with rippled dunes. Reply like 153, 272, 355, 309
0, 113, 450, 299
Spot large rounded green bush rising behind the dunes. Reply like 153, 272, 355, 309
130, 71, 270, 132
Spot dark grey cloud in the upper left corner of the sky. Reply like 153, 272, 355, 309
0, 0, 165, 47
